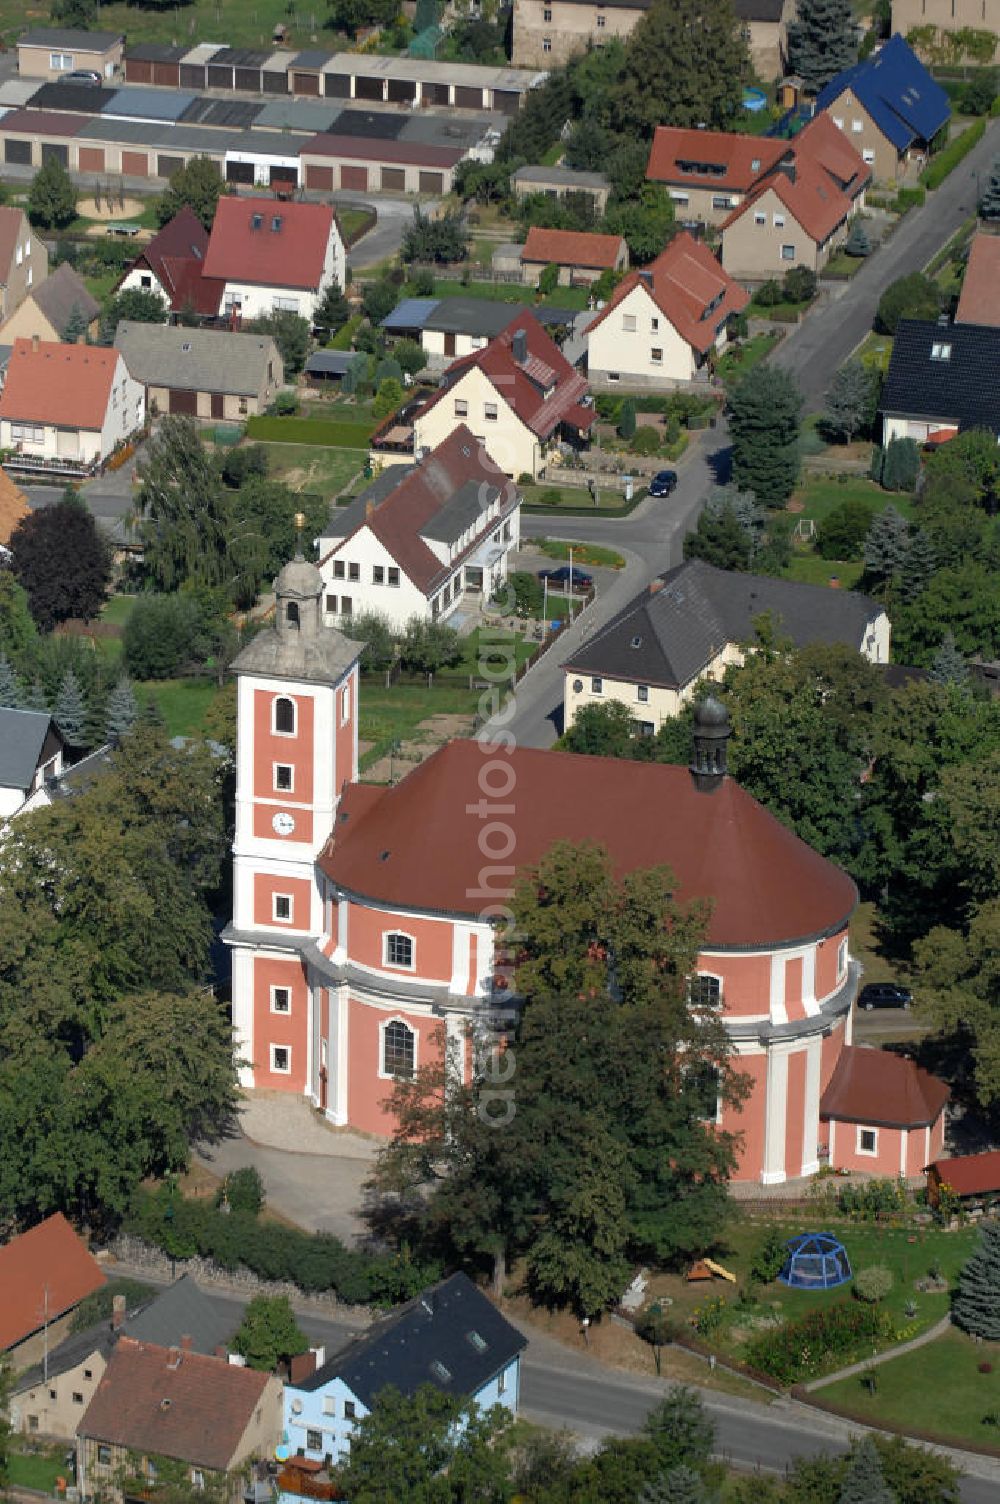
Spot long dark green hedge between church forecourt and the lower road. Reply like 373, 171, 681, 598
122, 1188, 442, 1305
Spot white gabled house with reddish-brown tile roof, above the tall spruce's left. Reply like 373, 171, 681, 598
586, 230, 750, 391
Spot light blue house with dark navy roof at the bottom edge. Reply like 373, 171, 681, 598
283, 1274, 526, 1467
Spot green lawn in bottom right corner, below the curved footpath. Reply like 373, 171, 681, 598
818, 1330, 1000, 1447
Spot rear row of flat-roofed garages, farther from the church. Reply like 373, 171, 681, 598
125, 42, 546, 114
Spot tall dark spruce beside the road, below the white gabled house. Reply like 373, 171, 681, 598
729, 365, 802, 507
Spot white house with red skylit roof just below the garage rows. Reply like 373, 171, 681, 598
203, 197, 346, 320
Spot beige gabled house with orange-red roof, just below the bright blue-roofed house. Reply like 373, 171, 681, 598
722, 114, 871, 281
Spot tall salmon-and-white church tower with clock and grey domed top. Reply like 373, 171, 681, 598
227, 553, 362, 1093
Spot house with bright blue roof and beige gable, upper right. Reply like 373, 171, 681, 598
817, 35, 952, 182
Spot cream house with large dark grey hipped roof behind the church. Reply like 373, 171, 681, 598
562, 559, 890, 735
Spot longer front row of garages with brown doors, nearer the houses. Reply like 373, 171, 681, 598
0, 110, 466, 196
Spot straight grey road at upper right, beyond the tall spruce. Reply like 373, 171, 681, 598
773, 120, 1000, 408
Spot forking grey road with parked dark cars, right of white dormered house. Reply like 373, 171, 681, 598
490, 424, 729, 747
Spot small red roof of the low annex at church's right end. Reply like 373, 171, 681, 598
820, 1045, 950, 1128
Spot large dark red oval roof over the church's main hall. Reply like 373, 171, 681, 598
319, 741, 857, 949
